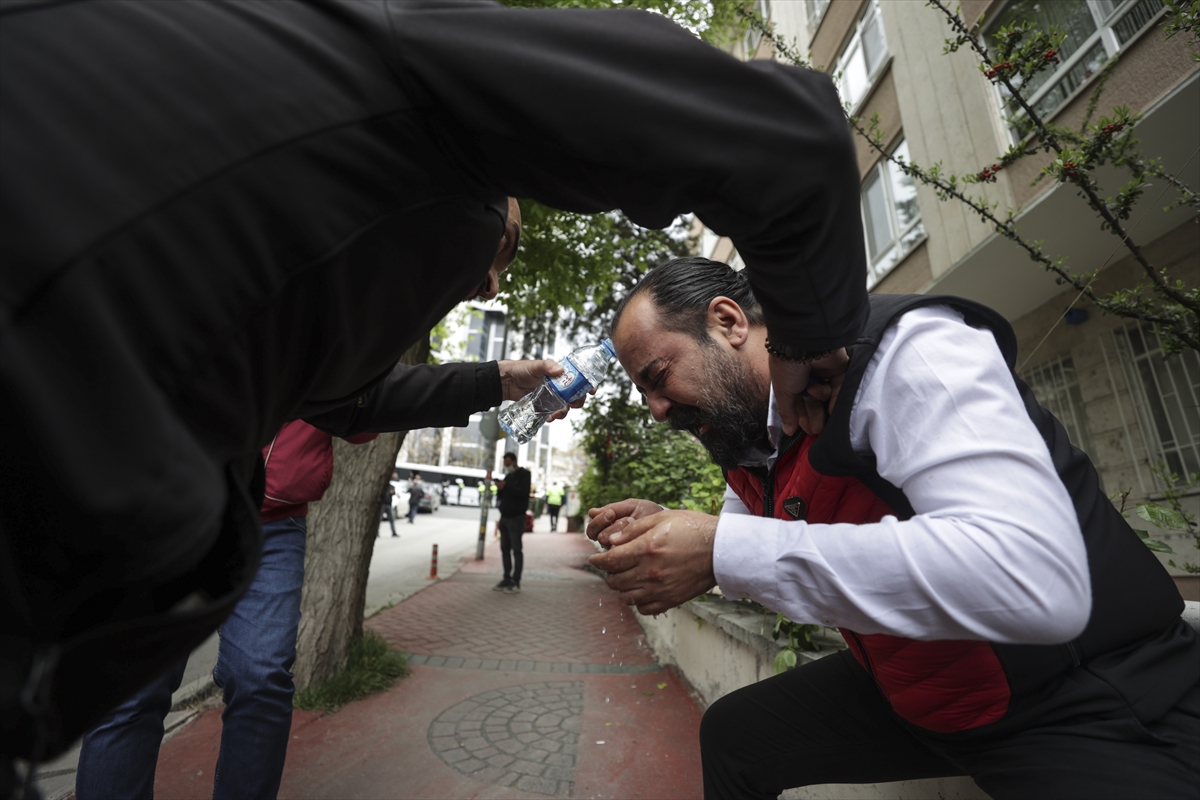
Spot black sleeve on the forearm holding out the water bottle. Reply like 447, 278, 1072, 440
305, 361, 503, 437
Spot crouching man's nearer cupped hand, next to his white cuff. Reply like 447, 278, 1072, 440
588, 510, 716, 614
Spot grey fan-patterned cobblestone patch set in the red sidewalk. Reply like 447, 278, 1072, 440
428, 681, 583, 798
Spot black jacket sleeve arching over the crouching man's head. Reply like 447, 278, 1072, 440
385, 0, 868, 350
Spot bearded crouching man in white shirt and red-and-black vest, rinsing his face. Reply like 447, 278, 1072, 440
588, 259, 1200, 799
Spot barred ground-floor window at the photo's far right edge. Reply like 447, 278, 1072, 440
1114, 324, 1200, 477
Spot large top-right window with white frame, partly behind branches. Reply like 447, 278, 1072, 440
988, 0, 1163, 139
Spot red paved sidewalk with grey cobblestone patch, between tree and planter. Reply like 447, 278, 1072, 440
146, 518, 702, 800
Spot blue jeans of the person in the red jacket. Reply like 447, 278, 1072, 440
76, 517, 307, 800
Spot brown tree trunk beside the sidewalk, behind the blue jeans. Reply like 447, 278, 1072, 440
293, 337, 430, 691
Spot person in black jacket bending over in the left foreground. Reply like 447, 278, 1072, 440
0, 0, 866, 771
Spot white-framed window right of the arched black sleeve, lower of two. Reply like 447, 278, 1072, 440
863, 140, 925, 288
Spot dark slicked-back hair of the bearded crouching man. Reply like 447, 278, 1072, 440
612, 257, 767, 342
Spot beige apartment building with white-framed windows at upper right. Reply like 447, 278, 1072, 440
702, 0, 1200, 587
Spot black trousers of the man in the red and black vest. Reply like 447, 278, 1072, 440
700, 651, 1200, 800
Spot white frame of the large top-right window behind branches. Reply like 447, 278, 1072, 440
984, 0, 1166, 144
